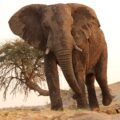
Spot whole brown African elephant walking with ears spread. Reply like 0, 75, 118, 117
9, 4, 112, 110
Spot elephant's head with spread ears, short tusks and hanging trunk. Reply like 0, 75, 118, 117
9, 4, 98, 93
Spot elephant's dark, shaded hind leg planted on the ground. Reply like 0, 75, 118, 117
85, 73, 99, 111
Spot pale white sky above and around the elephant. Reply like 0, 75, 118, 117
0, 0, 120, 83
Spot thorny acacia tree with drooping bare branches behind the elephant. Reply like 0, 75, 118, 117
0, 40, 49, 98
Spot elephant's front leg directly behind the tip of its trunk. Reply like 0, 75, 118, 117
73, 52, 88, 108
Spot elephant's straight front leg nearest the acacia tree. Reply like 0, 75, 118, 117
45, 53, 63, 110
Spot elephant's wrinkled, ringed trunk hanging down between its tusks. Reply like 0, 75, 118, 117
56, 50, 81, 95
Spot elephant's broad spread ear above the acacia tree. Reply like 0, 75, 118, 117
9, 4, 45, 49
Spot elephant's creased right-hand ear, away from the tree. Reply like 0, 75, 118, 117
72, 5, 100, 39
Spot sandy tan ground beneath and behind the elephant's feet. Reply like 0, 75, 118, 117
0, 82, 120, 120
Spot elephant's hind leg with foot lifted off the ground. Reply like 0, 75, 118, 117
95, 50, 112, 106
